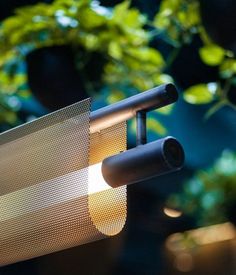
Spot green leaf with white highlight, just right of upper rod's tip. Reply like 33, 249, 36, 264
183, 83, 218, 104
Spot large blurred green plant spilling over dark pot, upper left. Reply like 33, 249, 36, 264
0, 0, 168, 126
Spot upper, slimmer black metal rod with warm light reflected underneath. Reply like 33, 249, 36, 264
90, 84, 178, 133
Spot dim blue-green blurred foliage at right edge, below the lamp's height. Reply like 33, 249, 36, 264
167, 151, 236, 226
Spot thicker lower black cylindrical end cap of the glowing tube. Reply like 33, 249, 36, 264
102, 137, 184, 187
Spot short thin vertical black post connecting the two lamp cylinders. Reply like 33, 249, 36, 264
136, 111, 147, 146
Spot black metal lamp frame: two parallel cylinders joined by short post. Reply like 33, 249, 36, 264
90, 84, 184, 187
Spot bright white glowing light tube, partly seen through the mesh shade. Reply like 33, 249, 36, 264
0, 163, 111, 221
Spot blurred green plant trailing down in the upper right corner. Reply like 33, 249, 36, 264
154, 0, 236, 117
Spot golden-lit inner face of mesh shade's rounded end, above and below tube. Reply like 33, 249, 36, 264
88, 122, 126, 236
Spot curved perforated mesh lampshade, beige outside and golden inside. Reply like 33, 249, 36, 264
0, 99, 126, 265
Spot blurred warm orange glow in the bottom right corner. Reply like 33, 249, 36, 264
166, 222, 236, 253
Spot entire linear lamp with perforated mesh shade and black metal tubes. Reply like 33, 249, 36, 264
0, 84, 184, 265
